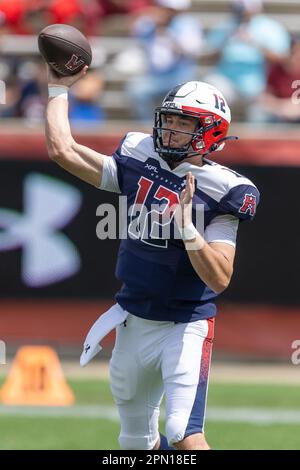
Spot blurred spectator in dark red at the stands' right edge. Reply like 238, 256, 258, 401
249, 38, 300, 123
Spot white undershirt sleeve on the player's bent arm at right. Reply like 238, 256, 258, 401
204, 214, 239, 247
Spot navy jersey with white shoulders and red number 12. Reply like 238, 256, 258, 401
102, 133, 259, 322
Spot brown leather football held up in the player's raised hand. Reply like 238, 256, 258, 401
38, 24, 92, 76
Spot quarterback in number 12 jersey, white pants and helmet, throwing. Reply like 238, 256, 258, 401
46, 68, 259, 450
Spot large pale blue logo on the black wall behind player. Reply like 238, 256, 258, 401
0, 173, 82, 287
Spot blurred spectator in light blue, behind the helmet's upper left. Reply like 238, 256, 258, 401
127, 0, 202, 122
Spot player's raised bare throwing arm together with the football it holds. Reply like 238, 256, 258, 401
39, 25, 108, 187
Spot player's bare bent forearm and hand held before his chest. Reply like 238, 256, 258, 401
176, 172, 235, 294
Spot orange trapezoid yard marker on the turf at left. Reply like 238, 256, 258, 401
0, 346, 75, 406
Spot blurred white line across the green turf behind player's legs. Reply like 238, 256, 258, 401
0, 405, 300, 424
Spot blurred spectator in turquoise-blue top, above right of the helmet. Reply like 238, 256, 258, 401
205, 0, 290, 104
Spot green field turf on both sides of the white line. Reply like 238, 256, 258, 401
0, 380, 300, 449
